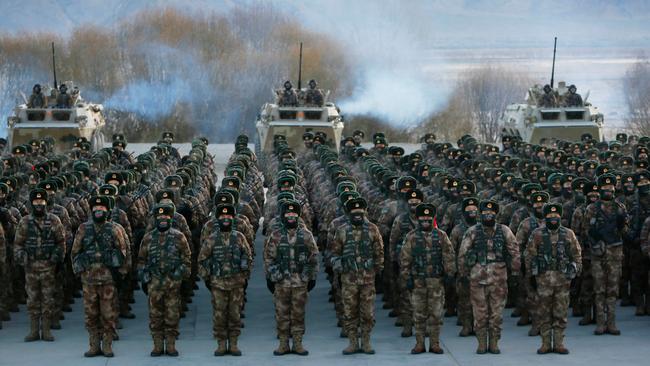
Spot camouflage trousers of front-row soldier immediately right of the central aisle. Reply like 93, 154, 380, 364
273, 286, 306, 337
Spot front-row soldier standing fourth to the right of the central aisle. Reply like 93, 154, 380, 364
458, 200, 521, 354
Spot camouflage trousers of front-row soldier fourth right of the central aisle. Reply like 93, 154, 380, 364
470, 269, 508, 334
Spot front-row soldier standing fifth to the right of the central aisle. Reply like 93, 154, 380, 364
522, 203, 582, 355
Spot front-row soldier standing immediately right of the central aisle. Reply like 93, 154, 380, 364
264, 200, 318, 356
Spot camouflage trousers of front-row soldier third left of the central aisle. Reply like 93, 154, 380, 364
83, 283, 117, 334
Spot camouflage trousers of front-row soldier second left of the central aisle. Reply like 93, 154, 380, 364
149, 279, 181, 338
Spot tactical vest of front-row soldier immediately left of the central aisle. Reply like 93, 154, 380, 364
210, 228, 248, 278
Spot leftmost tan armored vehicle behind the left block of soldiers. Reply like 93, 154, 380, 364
7, 82, 106, 152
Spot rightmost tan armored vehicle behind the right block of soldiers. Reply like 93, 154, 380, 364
500, 82, 604, 144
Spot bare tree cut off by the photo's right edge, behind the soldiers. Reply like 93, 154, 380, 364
623, 57, 650, 135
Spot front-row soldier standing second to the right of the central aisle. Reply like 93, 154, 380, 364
331, 198, 384, 355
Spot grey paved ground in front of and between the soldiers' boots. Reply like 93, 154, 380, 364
0, 147, 650, 366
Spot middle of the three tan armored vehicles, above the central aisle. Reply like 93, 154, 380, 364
256, 85, 343, 153
